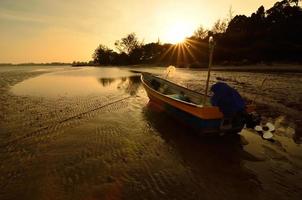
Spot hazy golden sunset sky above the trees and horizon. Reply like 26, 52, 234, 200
0, 0, 277, 63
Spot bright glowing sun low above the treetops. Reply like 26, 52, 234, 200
165, 22, 192, 44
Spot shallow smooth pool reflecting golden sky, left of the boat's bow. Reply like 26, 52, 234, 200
11, 68, 140, 97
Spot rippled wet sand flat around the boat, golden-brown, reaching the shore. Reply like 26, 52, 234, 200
0, 67, 302, 199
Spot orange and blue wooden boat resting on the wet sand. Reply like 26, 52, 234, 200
141, 73, 254, 133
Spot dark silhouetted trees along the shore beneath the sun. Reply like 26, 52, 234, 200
90, 0, 302, 67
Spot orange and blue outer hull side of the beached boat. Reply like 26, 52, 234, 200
142, 75, 252, 134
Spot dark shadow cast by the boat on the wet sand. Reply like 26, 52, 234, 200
143, 103, 261, 199
